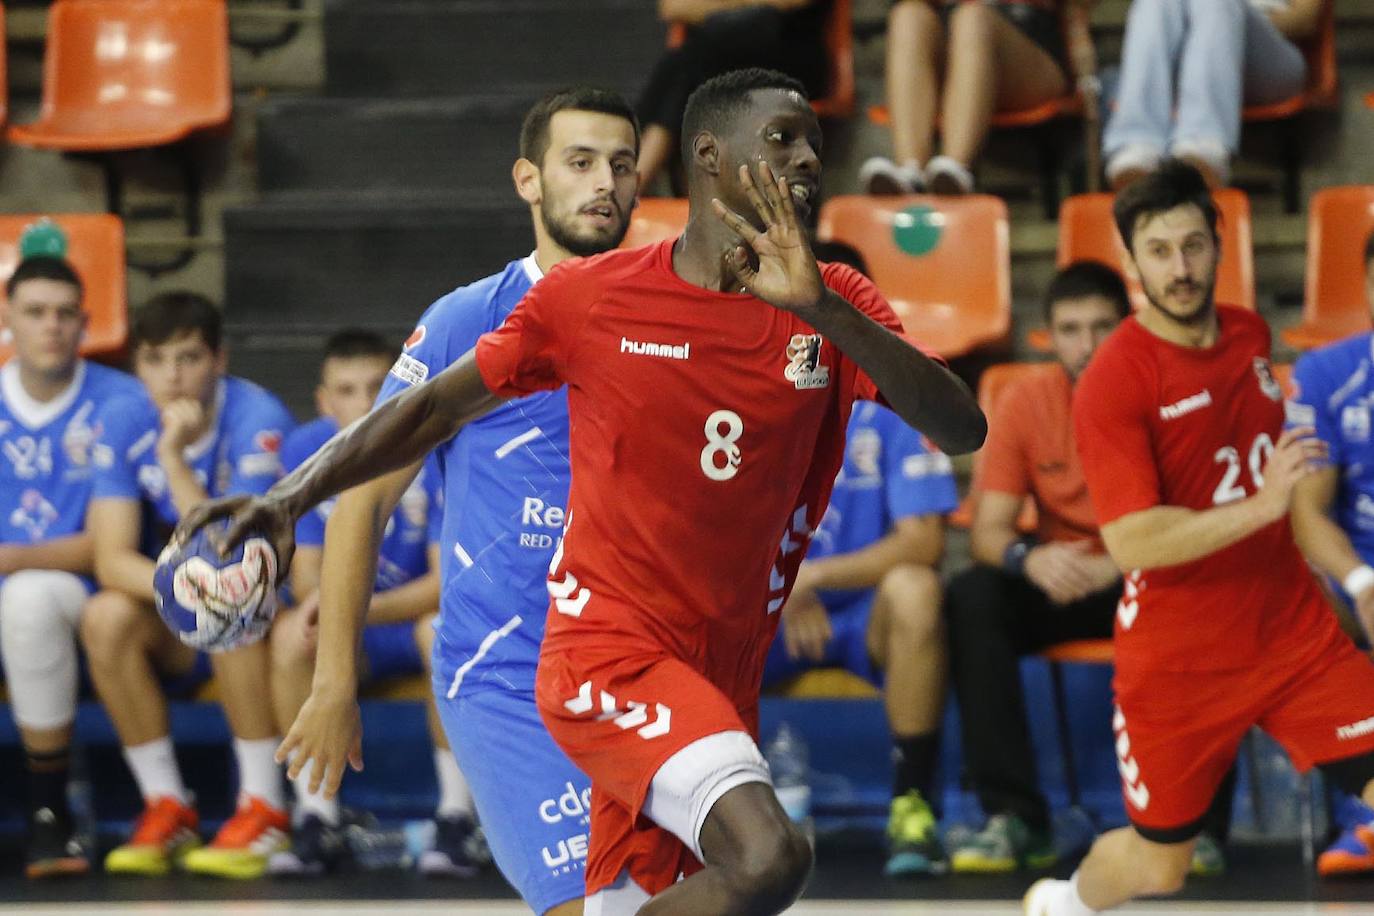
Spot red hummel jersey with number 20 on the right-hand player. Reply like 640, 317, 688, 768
1073, 306, 1330, 676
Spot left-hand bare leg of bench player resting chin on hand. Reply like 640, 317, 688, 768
81, 592, 195, 747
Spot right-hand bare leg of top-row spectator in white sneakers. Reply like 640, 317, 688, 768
941, 3, 1068, 168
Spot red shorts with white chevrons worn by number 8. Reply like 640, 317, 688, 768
534, 644, 758, 895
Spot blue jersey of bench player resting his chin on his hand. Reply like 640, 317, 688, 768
91, 378, 295, 556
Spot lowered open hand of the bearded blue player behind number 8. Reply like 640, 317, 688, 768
276, 687, 363, 798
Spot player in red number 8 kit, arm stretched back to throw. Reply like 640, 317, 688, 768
181, 70, 987, 915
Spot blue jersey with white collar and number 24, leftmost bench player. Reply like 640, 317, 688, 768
0, 360, 143, 544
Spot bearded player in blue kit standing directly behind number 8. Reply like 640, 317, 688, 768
270, 89, 639, 916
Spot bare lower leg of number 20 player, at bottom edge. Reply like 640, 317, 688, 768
1079, 827, 1197, 909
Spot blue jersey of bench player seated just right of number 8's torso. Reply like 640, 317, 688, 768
807, 401, 959, 595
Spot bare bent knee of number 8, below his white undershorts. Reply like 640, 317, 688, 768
639, 783, 812, 916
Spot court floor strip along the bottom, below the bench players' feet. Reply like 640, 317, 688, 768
0, 840, 1374, 916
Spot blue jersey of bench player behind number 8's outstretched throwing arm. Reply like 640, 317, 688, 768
282, 416, 442, 592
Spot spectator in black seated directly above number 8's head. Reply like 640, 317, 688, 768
636, 0, 830, 190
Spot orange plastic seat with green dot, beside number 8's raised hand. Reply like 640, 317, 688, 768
818, 194, 1011, 357
